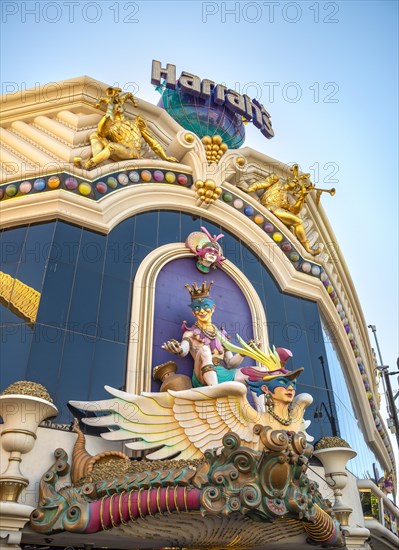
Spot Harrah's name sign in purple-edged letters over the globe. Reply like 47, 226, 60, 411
151, 59, 274, 139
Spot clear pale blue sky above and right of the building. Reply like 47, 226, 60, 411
1, 0, 398, 396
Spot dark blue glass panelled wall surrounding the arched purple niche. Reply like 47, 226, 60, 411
0, 211, 339, 440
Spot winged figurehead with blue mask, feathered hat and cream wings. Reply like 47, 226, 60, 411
71, 334, 313, 460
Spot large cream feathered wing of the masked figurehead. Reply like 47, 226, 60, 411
70, 382, 264, 460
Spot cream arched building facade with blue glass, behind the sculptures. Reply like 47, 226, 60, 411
0, 77, 398, 548
